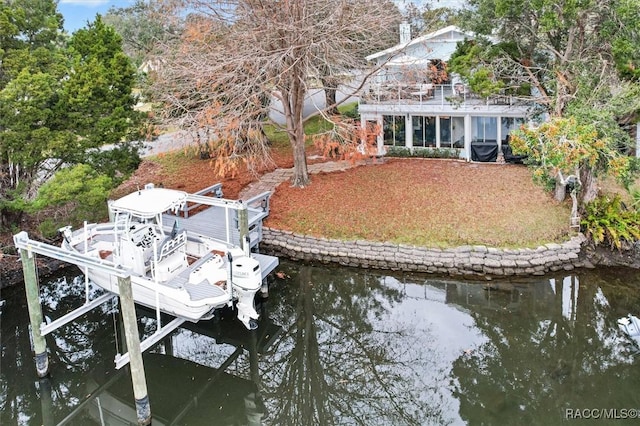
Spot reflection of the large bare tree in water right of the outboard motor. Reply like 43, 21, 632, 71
261, 265, 448, 425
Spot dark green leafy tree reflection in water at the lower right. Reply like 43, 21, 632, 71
448, 271, 640, 424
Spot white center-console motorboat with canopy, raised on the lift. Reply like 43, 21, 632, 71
61, 185, 262, 329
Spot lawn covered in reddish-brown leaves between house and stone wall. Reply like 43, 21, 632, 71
267, 159, 570, 248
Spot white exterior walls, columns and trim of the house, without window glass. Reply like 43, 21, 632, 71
359, 24, 530, 161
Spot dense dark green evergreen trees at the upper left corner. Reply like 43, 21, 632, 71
0, 5, 143, 227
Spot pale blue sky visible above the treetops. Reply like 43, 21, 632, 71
58, 0, 463, 34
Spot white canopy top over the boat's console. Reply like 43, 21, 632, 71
110, 188, 188, 219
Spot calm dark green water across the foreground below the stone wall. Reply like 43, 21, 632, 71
0, 262, 640, 426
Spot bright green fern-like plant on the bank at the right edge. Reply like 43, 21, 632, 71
581, 195, 640, 250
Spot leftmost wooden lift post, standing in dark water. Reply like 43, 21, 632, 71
20, 249, 49, 378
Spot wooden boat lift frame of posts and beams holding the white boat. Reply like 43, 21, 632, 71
13, 185, 278, 424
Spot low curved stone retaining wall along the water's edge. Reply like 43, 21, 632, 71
260, 227, 589, 276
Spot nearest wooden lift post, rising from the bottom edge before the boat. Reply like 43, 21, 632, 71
118, 277, 151, 425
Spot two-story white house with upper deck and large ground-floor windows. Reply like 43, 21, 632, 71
359, 24, 531, 162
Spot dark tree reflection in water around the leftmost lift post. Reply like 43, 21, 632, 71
0, 276, 115, 424
